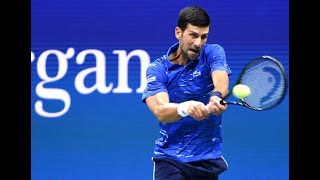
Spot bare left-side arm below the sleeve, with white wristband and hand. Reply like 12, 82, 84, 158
146, 92, 209, 123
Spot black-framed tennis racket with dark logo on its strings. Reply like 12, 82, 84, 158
220, 56, 288, 111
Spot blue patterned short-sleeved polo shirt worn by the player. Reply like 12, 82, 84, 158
142, 43, 232, 162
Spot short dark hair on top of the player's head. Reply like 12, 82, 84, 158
178, 6, 210, 31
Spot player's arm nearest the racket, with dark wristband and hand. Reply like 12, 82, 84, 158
207, 70, 229, 115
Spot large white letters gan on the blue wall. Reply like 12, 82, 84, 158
31, 48, 150, 118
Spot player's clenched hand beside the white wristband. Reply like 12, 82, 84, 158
188, 101, 210, 121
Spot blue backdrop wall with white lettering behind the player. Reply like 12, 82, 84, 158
31, 0, 289, 180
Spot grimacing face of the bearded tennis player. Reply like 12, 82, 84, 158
176, 24, 209, 60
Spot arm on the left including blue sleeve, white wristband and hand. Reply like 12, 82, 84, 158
142, 59, 209, 123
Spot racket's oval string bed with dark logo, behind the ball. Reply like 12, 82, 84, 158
240, 59, 286, 109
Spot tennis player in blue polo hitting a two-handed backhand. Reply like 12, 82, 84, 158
142, 6, 231, 180
